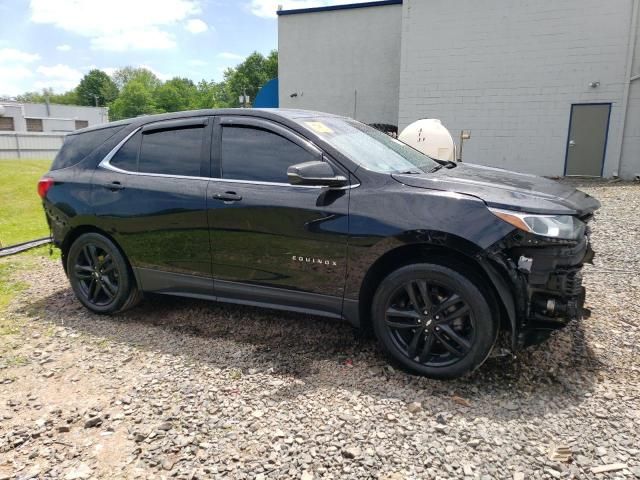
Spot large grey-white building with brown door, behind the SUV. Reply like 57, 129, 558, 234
278, 0, 640, 178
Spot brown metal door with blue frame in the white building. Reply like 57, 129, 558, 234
565, 103, 611, 177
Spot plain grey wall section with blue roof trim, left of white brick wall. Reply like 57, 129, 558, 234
278, 5, 402, 125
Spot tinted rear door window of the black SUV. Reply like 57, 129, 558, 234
138, 127, 204, 177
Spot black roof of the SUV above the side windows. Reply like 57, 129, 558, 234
69, 108, 348, 135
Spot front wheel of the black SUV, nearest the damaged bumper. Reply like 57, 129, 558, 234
371, 263, 499, 379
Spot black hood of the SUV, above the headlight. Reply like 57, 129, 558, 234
392, 163, 600, 216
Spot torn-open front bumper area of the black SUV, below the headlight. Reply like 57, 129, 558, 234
489, 231, 595, 348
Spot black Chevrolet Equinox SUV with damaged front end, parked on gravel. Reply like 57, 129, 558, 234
38, 109, 600, 378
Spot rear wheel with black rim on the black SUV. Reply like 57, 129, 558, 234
67, 233, 142, 315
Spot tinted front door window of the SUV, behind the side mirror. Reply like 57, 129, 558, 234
222, 126, 318, 183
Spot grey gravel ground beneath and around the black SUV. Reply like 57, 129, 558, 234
0, 183, 640, 480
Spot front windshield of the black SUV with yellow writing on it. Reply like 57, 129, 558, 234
300, 117, 439, 173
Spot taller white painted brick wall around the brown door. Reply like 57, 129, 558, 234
398, 0, 640, 176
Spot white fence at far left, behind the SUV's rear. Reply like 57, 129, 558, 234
0, 132, 65, 160
